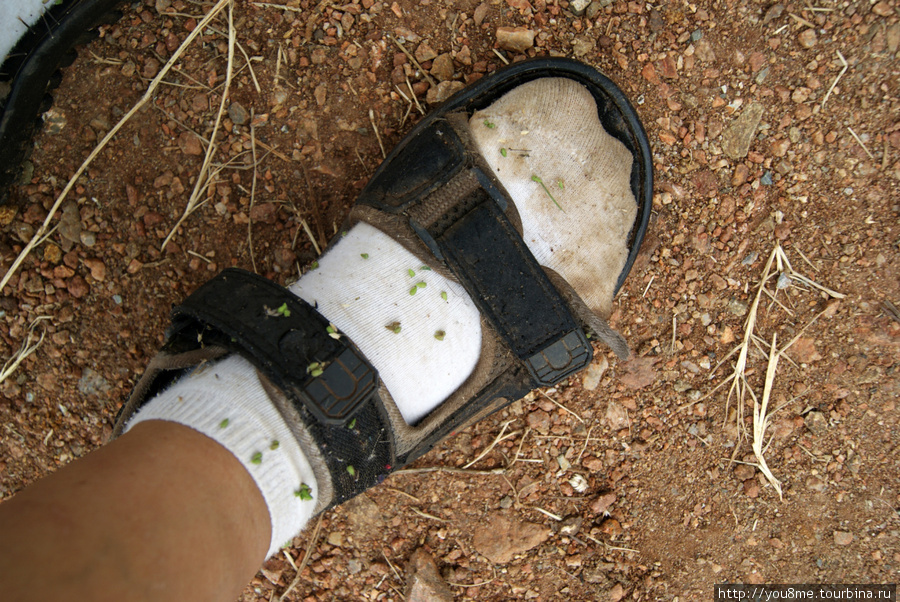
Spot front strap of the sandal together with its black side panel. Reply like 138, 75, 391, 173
359, 118, 593, 387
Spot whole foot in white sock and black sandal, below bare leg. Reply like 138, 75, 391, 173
117, 59, 651, 546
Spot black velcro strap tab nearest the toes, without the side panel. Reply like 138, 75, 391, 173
408, 167, 592, 386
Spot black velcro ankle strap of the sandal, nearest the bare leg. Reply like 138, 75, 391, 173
170, 268, 378, 425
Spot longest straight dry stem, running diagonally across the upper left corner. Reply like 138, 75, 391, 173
0, 0, 232, 291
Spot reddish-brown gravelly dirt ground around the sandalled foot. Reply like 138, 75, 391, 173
0, 0, 900, 602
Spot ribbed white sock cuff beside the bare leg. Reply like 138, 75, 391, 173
125, 356, 318, 558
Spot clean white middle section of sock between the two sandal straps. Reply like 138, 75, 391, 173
290, 224, 481, 424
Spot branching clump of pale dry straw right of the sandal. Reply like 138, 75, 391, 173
704, 243, 844, 498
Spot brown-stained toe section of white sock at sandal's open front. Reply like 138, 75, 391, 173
469, 78, 637, 318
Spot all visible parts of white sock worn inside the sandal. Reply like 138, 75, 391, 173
129, 80, 636, 555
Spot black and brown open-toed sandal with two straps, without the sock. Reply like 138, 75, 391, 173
114, 58, 653, 510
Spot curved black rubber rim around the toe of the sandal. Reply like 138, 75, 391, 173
370, 57, 653, 293
